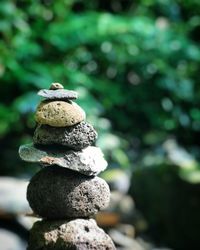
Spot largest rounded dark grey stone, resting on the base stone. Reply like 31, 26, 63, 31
27, 166, 110, 219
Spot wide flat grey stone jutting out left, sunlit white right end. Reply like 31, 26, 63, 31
19, 144, 107, 176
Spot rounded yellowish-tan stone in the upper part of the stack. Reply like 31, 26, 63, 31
35, 100, 86, 127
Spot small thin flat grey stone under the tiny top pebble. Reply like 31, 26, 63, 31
38, 89, 78, 100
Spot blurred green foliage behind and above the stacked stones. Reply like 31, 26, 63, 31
0, 0, 200, 174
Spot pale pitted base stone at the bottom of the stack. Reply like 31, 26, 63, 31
27, 219, 116, 250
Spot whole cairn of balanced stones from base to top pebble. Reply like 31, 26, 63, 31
19, 83, 116, 250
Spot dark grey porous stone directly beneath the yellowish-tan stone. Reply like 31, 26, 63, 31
33, 121, 97, 150
